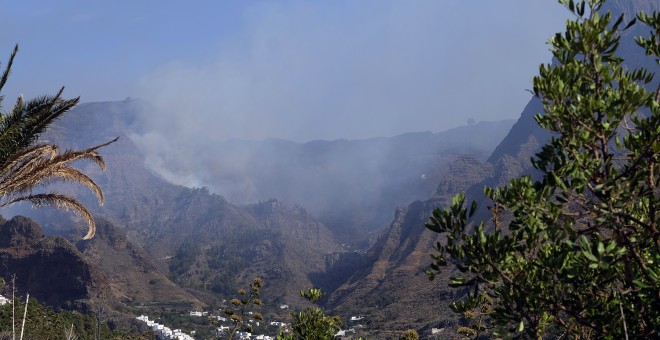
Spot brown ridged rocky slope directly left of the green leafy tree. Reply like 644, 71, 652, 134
328, 156, 495, 338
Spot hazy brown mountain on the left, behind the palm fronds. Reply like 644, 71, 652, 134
14, 101, 343, 308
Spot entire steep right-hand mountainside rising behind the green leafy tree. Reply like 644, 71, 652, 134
328, 0, 660, 338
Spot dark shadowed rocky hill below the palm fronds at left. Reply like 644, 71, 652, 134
0, 216, 109, 308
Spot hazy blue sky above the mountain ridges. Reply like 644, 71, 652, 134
0, 0, 567, 143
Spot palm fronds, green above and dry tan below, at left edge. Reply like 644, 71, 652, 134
0, 45, 117, 239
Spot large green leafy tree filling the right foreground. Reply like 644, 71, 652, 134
426, 0, 660, 339
